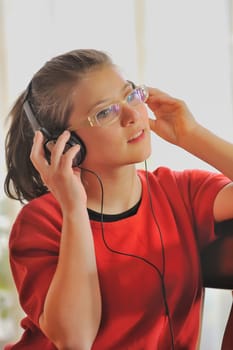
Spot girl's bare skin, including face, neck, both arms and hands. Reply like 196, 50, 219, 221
31, 67, 233, 349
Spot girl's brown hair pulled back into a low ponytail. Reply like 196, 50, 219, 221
4, 49, 113, 203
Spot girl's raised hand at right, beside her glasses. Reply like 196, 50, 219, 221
146, 88, 198, 146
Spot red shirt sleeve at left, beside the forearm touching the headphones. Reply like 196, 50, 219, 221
9, 195, 62, 326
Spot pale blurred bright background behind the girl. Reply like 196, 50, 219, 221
0, 0, 233, 350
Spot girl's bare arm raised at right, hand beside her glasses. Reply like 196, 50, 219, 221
147, 88, 233, 222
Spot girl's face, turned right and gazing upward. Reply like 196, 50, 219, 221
70, 66, 151, 169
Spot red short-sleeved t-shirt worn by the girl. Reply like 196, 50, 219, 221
4, 168, 229, 350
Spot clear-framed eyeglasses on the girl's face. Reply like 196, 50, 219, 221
87, 85, 149, 126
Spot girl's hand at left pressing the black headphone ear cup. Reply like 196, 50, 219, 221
30, 131, 87, 211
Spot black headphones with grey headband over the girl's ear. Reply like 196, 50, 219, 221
23, 94, 86, 167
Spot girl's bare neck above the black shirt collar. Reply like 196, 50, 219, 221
82, 165, 141, 214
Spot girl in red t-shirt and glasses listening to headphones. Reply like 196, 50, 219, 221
5, 50, 233, 350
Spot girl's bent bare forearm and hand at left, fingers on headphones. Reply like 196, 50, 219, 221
31, 132, 101, 349
